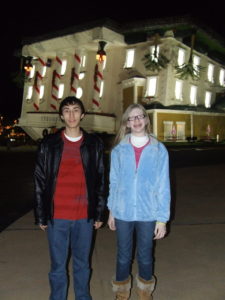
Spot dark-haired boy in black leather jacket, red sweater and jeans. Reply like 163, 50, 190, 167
34, 97, 105, 300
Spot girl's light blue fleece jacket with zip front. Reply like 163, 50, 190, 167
107, 135, 170, 222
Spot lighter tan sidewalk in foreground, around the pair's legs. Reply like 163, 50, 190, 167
0, 212, 225, 300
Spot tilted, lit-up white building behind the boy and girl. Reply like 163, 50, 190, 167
19, 20, 225, 140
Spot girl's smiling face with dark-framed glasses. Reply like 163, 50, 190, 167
127, 108, 148, 136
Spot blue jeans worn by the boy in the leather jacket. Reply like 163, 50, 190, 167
47, 219, 93, 300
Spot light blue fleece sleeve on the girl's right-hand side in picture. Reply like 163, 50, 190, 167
156, 143, 171, 222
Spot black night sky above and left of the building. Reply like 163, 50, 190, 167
0, 0, 225, 118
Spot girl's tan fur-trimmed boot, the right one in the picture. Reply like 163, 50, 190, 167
136, 275, 155, 300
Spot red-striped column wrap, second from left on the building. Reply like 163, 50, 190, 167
50, 56, 62, 111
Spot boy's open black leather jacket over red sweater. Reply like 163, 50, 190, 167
34, 130, 106, 225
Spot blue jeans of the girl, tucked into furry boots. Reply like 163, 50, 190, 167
115, 219, 155, 281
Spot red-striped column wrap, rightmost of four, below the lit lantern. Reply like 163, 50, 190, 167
92, 61, 104, 110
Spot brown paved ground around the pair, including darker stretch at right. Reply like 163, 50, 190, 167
0, 148, 225, 300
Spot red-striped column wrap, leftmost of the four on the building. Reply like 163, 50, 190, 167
33, 57, 46, 110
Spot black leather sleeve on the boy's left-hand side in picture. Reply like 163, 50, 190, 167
34, 142, 47, 225
